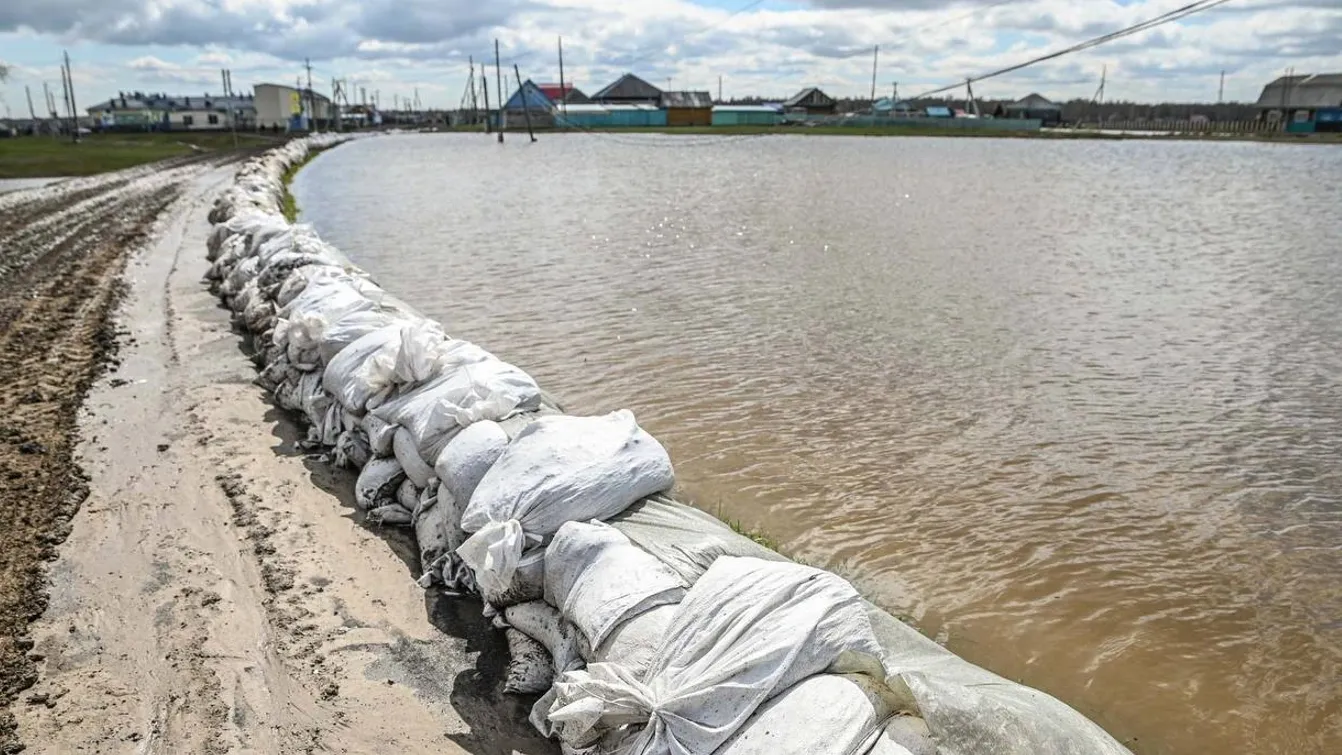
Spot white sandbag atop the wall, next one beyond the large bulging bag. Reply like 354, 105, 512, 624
370, 358, 541, 460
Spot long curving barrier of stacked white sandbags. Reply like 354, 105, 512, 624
208, 135, 1129, 755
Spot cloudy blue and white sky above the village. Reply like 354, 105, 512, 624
0, 0, 1342, 117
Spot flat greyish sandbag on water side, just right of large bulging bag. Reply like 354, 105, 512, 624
609, 496, 788, 587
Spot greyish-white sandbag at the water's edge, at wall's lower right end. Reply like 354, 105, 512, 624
863, 601, 1131, 755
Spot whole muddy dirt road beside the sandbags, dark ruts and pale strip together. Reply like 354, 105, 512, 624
0, 162, 553, 754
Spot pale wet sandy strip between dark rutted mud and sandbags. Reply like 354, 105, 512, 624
0, 166, 554, 754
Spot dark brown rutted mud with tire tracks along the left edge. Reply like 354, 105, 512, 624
0, 156, 235, 754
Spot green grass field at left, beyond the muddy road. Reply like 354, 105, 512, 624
0, 131, 279, 178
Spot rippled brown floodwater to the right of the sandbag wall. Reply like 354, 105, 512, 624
295, 134, 1342, 755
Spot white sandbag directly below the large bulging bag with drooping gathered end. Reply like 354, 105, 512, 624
545, 522, 684, 648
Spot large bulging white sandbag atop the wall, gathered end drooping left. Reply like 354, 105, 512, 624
458, 410, 675, 600
